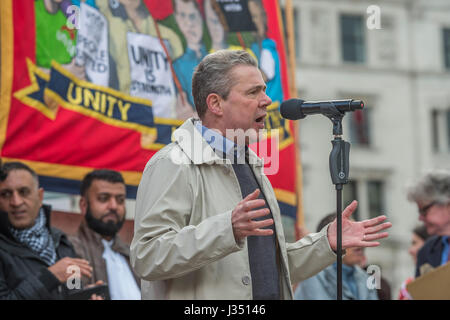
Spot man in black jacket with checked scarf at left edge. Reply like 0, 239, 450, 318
0, 162, 92, 299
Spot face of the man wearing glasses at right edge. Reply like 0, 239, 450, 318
417, 203, 450, 236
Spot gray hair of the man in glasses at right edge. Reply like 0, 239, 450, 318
408, 170, 450, 205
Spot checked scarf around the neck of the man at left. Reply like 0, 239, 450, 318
9, 209, 56, 266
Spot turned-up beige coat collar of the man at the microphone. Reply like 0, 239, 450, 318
172, 118, 264, 167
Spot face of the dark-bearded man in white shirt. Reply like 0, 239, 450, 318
80, 180, 126, 230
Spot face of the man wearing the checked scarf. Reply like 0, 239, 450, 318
0, 169, 44, 229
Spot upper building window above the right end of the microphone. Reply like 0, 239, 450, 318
340, 15, 366, 63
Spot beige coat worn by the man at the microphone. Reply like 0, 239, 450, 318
130, 119, 336, 300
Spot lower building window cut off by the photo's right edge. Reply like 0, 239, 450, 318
431, 109, 450, 153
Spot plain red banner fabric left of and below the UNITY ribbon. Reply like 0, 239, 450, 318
1, 1, 156, 172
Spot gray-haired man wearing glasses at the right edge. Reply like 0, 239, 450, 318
408, 170, 450, 277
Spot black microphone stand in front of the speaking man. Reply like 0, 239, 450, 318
324, 106, 350, 300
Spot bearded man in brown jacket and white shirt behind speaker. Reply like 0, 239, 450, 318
69, 169, 141, 300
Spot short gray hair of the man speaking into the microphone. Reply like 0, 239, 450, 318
192, 50, 258, 118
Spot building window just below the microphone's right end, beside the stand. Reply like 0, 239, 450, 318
347, 107, 372, 147
